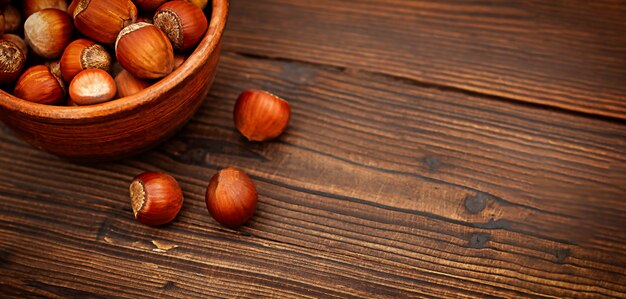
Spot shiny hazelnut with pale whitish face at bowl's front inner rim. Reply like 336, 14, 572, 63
69, 69, 117, 106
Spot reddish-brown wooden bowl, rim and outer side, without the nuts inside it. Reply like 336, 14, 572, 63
0, 0, 228, 162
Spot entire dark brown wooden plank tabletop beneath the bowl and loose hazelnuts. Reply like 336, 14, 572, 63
0, 0, 626, 298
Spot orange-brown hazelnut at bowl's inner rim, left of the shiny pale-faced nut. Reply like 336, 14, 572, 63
13, 65, 65, 105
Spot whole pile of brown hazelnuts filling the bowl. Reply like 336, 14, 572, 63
0, 0, 208, 106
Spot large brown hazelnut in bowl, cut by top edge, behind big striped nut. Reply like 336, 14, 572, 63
70, 0, 137, 44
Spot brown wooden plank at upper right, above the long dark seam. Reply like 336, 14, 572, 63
224, 0, 626, 119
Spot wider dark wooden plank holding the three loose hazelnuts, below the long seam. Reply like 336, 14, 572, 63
0, 53, 626, 298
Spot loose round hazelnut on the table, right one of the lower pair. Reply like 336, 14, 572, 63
205, 167, 258, 226
